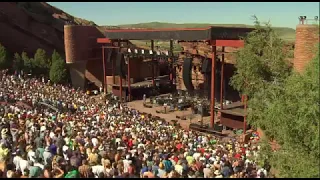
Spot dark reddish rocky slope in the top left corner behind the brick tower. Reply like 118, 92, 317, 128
0, 2, 95, 56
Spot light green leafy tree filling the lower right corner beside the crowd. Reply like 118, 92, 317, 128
248, 48, 320, 178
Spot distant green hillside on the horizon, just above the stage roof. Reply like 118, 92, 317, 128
118, 22, 295, 41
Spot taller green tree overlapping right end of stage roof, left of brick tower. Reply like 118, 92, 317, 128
231, 16, 291, 97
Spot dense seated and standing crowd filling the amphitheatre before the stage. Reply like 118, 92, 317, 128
0, 72, 268, 178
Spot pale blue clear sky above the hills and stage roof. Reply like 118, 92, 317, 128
48, 2, 319, 28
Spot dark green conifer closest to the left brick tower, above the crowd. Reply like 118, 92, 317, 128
50, 50, 67, 83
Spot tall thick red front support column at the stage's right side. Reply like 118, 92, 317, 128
210, 42, 217, 128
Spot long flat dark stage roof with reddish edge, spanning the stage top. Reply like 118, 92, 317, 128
104, 26, 254, 41
